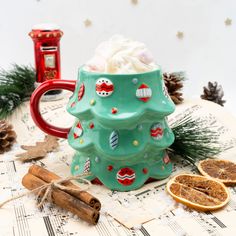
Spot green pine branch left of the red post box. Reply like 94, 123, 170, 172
0, 64, 36, 119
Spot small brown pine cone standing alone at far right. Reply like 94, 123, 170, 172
201, 82, 226, 106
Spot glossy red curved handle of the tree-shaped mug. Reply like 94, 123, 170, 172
30, 80, 76, 138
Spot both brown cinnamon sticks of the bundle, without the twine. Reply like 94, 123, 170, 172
22, 165, 101, 225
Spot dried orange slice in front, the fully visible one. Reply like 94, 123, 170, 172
166, 174, 230, 211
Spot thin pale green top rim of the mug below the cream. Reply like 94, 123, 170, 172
79, 65, 161, 77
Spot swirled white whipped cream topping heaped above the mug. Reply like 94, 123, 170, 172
85, 35, 158, 74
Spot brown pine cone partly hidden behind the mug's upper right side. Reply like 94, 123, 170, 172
163, 72, 185, 104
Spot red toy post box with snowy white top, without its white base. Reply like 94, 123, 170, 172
29, 25, 63, 83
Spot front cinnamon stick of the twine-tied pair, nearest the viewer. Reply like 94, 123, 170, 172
22, 173, 100, 225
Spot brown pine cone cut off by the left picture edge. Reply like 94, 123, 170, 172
0, 120, 16, 154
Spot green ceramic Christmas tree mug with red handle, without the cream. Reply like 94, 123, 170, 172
30, 67, 175, 191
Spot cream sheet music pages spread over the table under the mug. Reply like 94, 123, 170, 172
0, 96, 236, 236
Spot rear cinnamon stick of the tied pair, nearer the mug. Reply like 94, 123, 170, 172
28, 165, 101, 211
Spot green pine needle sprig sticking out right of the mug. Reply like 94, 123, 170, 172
168, 115, 222, 164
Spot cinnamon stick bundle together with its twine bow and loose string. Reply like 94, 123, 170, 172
20, 165, 100, 225
